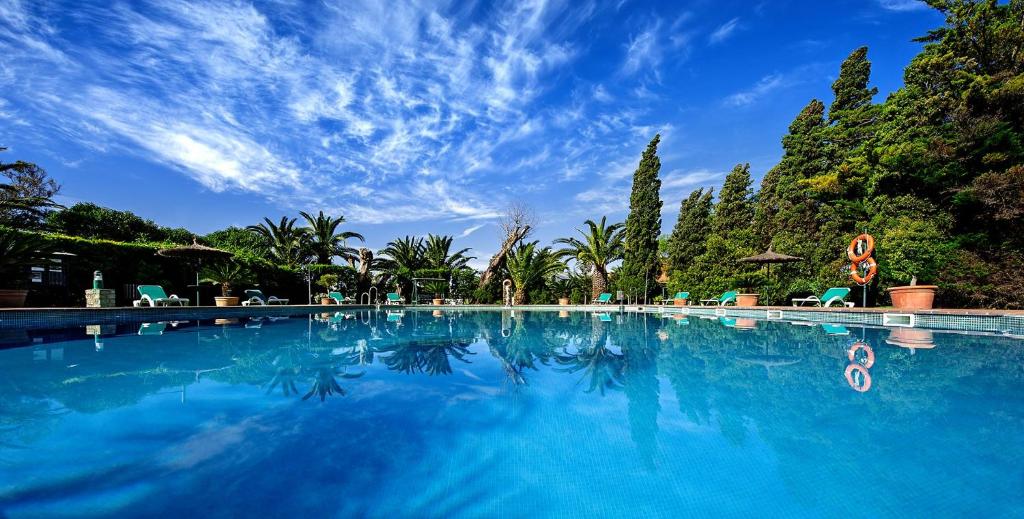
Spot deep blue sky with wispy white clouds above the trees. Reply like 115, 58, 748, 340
0, 0, 942, 265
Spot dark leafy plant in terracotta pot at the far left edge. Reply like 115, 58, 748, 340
0, 229, 50, 307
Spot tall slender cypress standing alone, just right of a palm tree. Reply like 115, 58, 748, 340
620, 134, 662, 296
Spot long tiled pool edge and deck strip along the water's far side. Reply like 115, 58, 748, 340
0, 304, 1024, 337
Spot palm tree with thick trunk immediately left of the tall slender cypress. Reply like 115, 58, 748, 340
555, 216, 625, 298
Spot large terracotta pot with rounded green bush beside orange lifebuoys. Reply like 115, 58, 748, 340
879, 218, 949, 310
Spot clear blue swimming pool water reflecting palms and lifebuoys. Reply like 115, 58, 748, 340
0, 310, 1024, 518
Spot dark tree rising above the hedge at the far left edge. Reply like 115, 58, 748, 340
0, 147, 60, 228
